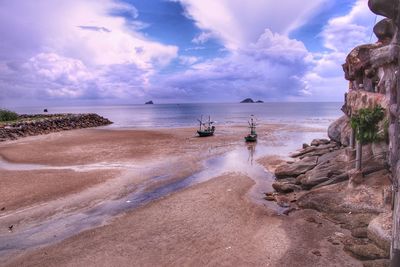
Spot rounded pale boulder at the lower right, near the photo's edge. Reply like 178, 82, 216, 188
367, 212, 392, 251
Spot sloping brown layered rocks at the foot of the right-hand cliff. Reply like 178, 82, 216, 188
265, 136, 392, 266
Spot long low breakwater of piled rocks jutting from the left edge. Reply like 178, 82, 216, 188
0, 113, 112, 142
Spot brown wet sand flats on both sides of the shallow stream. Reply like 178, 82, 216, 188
0, 125, 361, 266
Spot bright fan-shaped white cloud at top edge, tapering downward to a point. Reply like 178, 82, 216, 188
176, 0, 326, 50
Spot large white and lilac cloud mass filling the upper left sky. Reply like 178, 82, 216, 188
0, 0, 178, 102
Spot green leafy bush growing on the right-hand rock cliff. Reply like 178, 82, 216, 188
350, 105, 385, 144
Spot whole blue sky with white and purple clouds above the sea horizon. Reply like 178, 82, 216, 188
0, 0, 379, 107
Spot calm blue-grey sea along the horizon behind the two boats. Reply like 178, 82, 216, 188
13, 102, 343, 128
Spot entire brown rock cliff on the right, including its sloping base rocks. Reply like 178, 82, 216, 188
266, 0, 400, 266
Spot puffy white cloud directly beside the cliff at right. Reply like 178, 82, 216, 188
303, 0, 376, 100
